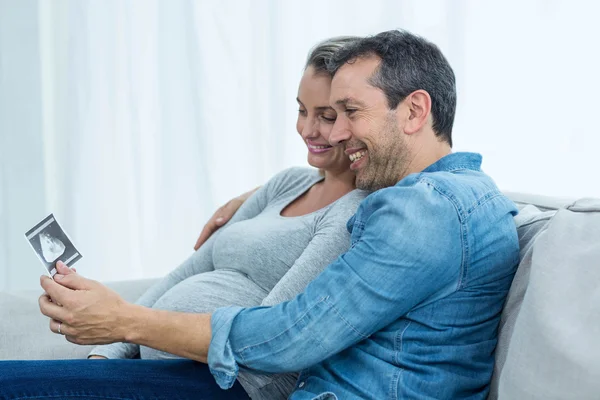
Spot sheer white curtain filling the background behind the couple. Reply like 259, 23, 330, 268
0, 0, 600, 289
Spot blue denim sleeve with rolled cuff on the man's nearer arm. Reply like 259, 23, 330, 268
208, 182, 465, 388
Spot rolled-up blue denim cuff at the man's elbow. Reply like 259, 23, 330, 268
208, 307, 243, 390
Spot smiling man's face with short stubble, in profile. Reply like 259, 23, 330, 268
329, 57, 409, 191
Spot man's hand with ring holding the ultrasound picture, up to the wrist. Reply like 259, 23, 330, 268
39, 262, 130, 344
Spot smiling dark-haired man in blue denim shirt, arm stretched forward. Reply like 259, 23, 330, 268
35, 31, 519, 399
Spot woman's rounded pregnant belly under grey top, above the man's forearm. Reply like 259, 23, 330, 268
152, 270, 268, 313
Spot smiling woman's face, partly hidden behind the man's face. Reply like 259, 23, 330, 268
296, 67, 350, 172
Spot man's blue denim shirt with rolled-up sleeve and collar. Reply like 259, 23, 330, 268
208, 153, 519, 400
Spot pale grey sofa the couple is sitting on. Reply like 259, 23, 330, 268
0, 193, 600, 400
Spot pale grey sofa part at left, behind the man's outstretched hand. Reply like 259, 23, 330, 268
0, 279, 156, 360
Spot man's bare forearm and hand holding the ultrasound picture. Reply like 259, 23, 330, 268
39, 263, 212, 363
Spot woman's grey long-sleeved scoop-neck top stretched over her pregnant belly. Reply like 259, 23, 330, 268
90, 167, 367, 399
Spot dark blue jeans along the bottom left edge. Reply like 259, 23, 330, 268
0, 360, 249, 400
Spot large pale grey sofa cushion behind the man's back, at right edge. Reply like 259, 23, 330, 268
490, 200, 600, 400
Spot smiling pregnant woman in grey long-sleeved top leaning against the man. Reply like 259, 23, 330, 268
0, 38, 366, 399
